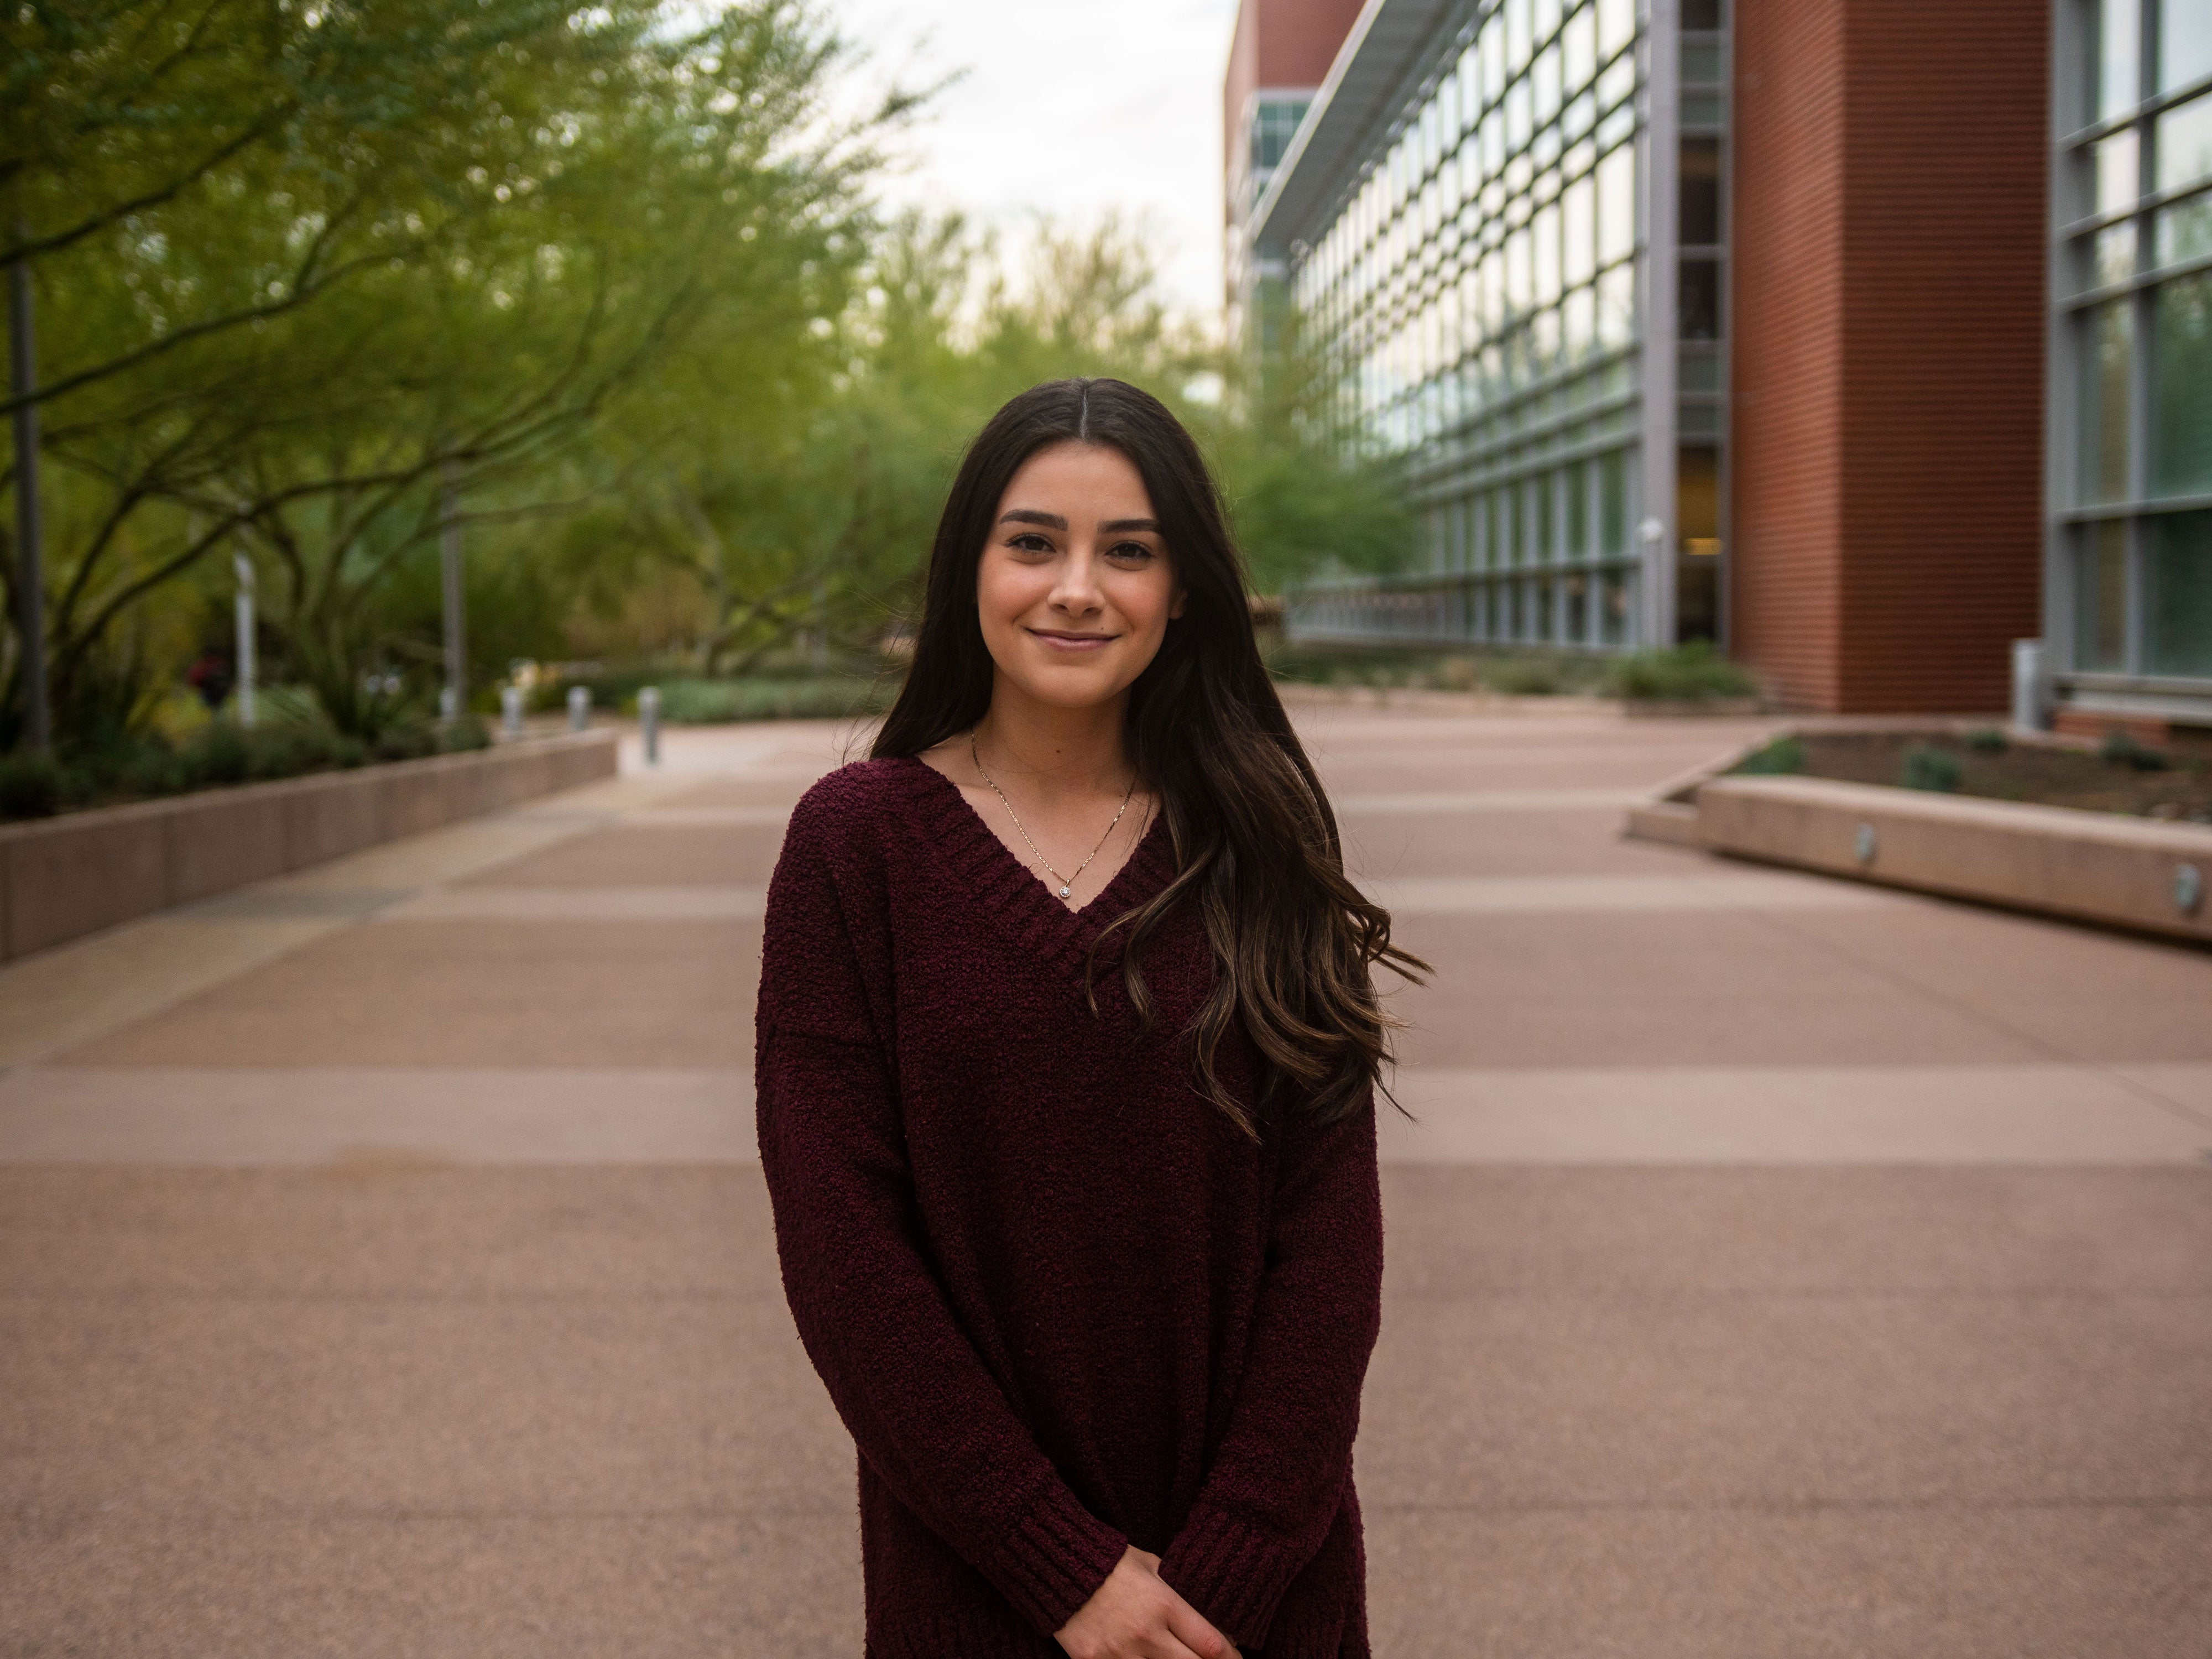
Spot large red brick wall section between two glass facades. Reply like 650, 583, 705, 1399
1730, 0, 2048, 712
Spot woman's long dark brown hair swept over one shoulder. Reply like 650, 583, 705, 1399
872, 380, 1429, 1135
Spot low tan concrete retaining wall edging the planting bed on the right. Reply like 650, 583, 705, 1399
1668, 776, 2212, 942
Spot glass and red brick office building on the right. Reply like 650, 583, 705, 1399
1245, 0, 2212, 712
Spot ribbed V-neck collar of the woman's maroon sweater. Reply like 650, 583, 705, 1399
902, 754, 1175, 995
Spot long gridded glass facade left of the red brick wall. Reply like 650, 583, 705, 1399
1292, 0, 1646, 646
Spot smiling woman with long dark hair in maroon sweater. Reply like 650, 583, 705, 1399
757, 380, 1425, 1659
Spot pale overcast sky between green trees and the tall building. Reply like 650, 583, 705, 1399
827, 0, 1237, 312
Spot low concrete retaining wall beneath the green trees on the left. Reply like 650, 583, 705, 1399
0, 732, 617, 960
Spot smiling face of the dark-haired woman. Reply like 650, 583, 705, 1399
975, 442, 1183, 708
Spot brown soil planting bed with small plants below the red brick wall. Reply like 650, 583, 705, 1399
1734, 728, 2212, 825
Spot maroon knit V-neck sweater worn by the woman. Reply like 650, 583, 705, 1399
754, 759, 1383, 1659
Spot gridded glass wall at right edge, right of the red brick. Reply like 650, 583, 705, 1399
2051, 0, 2212, 692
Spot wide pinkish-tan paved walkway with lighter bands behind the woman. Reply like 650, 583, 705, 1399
0, 710, 2212, 1659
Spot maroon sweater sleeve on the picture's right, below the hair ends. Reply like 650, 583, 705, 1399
1159, 1095, 1383, 1648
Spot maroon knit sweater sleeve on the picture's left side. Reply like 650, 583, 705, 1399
754, 814, 1128, 1637
